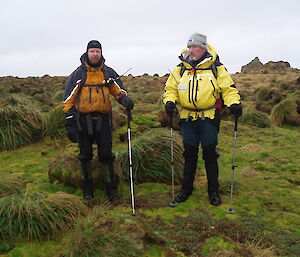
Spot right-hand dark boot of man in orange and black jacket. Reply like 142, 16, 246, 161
102, 163, 119, 202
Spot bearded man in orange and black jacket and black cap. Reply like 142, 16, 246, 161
64, 40, 134, 201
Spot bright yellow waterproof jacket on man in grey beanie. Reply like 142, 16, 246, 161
163, 45, 240, 120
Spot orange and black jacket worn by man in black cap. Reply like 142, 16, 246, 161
64, 54, 127, 114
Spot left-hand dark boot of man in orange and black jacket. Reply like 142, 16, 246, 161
80, 161, 94, 200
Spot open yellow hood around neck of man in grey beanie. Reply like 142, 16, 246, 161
179, 45, 217, 68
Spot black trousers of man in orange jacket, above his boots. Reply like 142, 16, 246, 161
77, 114, 114, 163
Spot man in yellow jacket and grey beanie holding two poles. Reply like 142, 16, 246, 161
163, 33, 242, 207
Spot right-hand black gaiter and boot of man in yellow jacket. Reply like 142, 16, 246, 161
203, 145, 221, 206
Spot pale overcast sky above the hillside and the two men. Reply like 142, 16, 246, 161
0, 0, 300, 77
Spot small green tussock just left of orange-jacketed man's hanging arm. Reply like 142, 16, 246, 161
44, 106, 66, 139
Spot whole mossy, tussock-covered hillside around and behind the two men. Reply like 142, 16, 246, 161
0, 63, 300, 257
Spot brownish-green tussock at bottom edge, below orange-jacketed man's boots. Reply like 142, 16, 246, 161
61, 207, 144, 257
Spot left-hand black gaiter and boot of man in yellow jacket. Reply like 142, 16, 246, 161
169, 144, 198, 207
